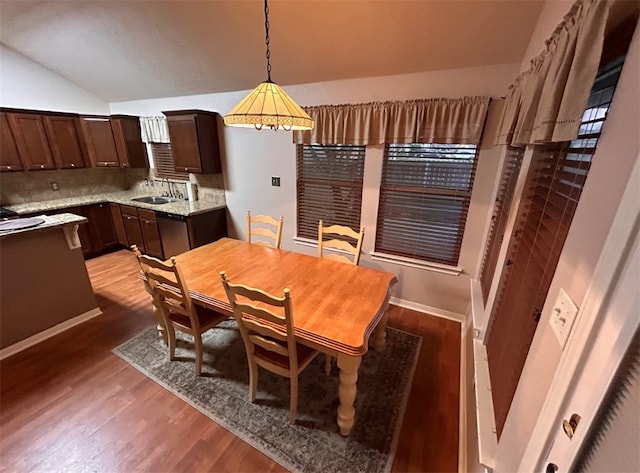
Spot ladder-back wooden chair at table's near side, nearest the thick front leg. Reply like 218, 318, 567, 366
220, 271, 318, 424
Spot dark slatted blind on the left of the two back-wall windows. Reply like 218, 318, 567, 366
296, 145, 366, 240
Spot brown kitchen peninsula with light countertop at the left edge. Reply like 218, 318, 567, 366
0, 213, 101, 359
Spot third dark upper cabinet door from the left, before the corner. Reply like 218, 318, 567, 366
44, 115, 87, 169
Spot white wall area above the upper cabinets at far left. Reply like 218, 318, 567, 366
0, 44, 109, 114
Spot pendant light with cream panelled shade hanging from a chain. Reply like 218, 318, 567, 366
224, 0, 313, 131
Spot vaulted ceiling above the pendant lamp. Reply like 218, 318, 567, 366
0, 0, 543, 102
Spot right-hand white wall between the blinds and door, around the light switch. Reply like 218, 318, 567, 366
495, 8, 640, 472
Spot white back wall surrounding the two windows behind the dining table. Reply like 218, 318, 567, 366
111, 64, 519, 314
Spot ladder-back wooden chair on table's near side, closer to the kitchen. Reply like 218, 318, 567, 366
132, 245, 229, 376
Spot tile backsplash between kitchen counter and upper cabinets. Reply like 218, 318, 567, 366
0, 168, 225, 205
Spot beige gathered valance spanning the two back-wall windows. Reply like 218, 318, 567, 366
293, 97, 490, 145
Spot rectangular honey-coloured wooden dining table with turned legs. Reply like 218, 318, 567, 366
176, 238, 397, 436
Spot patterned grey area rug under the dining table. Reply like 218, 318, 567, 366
113, 320, 422, 473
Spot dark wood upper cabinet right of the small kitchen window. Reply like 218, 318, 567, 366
162, 110, 222, 174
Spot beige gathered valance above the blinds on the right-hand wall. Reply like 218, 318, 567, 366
497, 0, 640, 145
